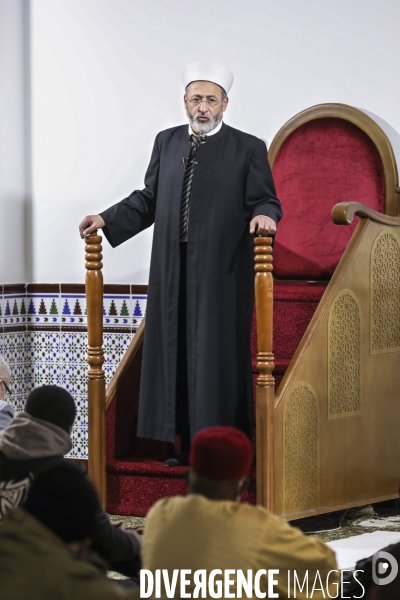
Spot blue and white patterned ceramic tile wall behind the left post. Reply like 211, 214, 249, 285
0, 284, 147, 458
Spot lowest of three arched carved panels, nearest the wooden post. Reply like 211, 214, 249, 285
284, 382, 318, 513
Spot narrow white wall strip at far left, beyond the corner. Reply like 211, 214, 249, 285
0, 0, 31, 283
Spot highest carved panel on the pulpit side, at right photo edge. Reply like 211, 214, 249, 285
371, 230, 400, 354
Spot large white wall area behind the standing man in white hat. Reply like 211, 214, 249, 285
31, 0, 400, 283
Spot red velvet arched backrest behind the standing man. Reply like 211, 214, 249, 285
273, 118, 384, 280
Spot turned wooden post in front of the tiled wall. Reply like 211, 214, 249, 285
85, 231, 106, 507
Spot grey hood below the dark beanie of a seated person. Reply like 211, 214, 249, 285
0, 412, 72, 460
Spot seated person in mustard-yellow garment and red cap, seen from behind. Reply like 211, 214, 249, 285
141, 427, 339, 600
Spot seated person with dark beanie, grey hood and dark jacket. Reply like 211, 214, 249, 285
0, 385, 141, 577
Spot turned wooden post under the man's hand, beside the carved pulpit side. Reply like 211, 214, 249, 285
254, 237, 275, 511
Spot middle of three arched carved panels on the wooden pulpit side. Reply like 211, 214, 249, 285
328, 290, 361, 419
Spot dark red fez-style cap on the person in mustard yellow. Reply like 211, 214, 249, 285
189, 427, 253, 481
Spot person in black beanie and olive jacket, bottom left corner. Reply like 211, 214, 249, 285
0, 460, 139, 600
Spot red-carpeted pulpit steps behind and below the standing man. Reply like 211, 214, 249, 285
107, 281, 326, 516
